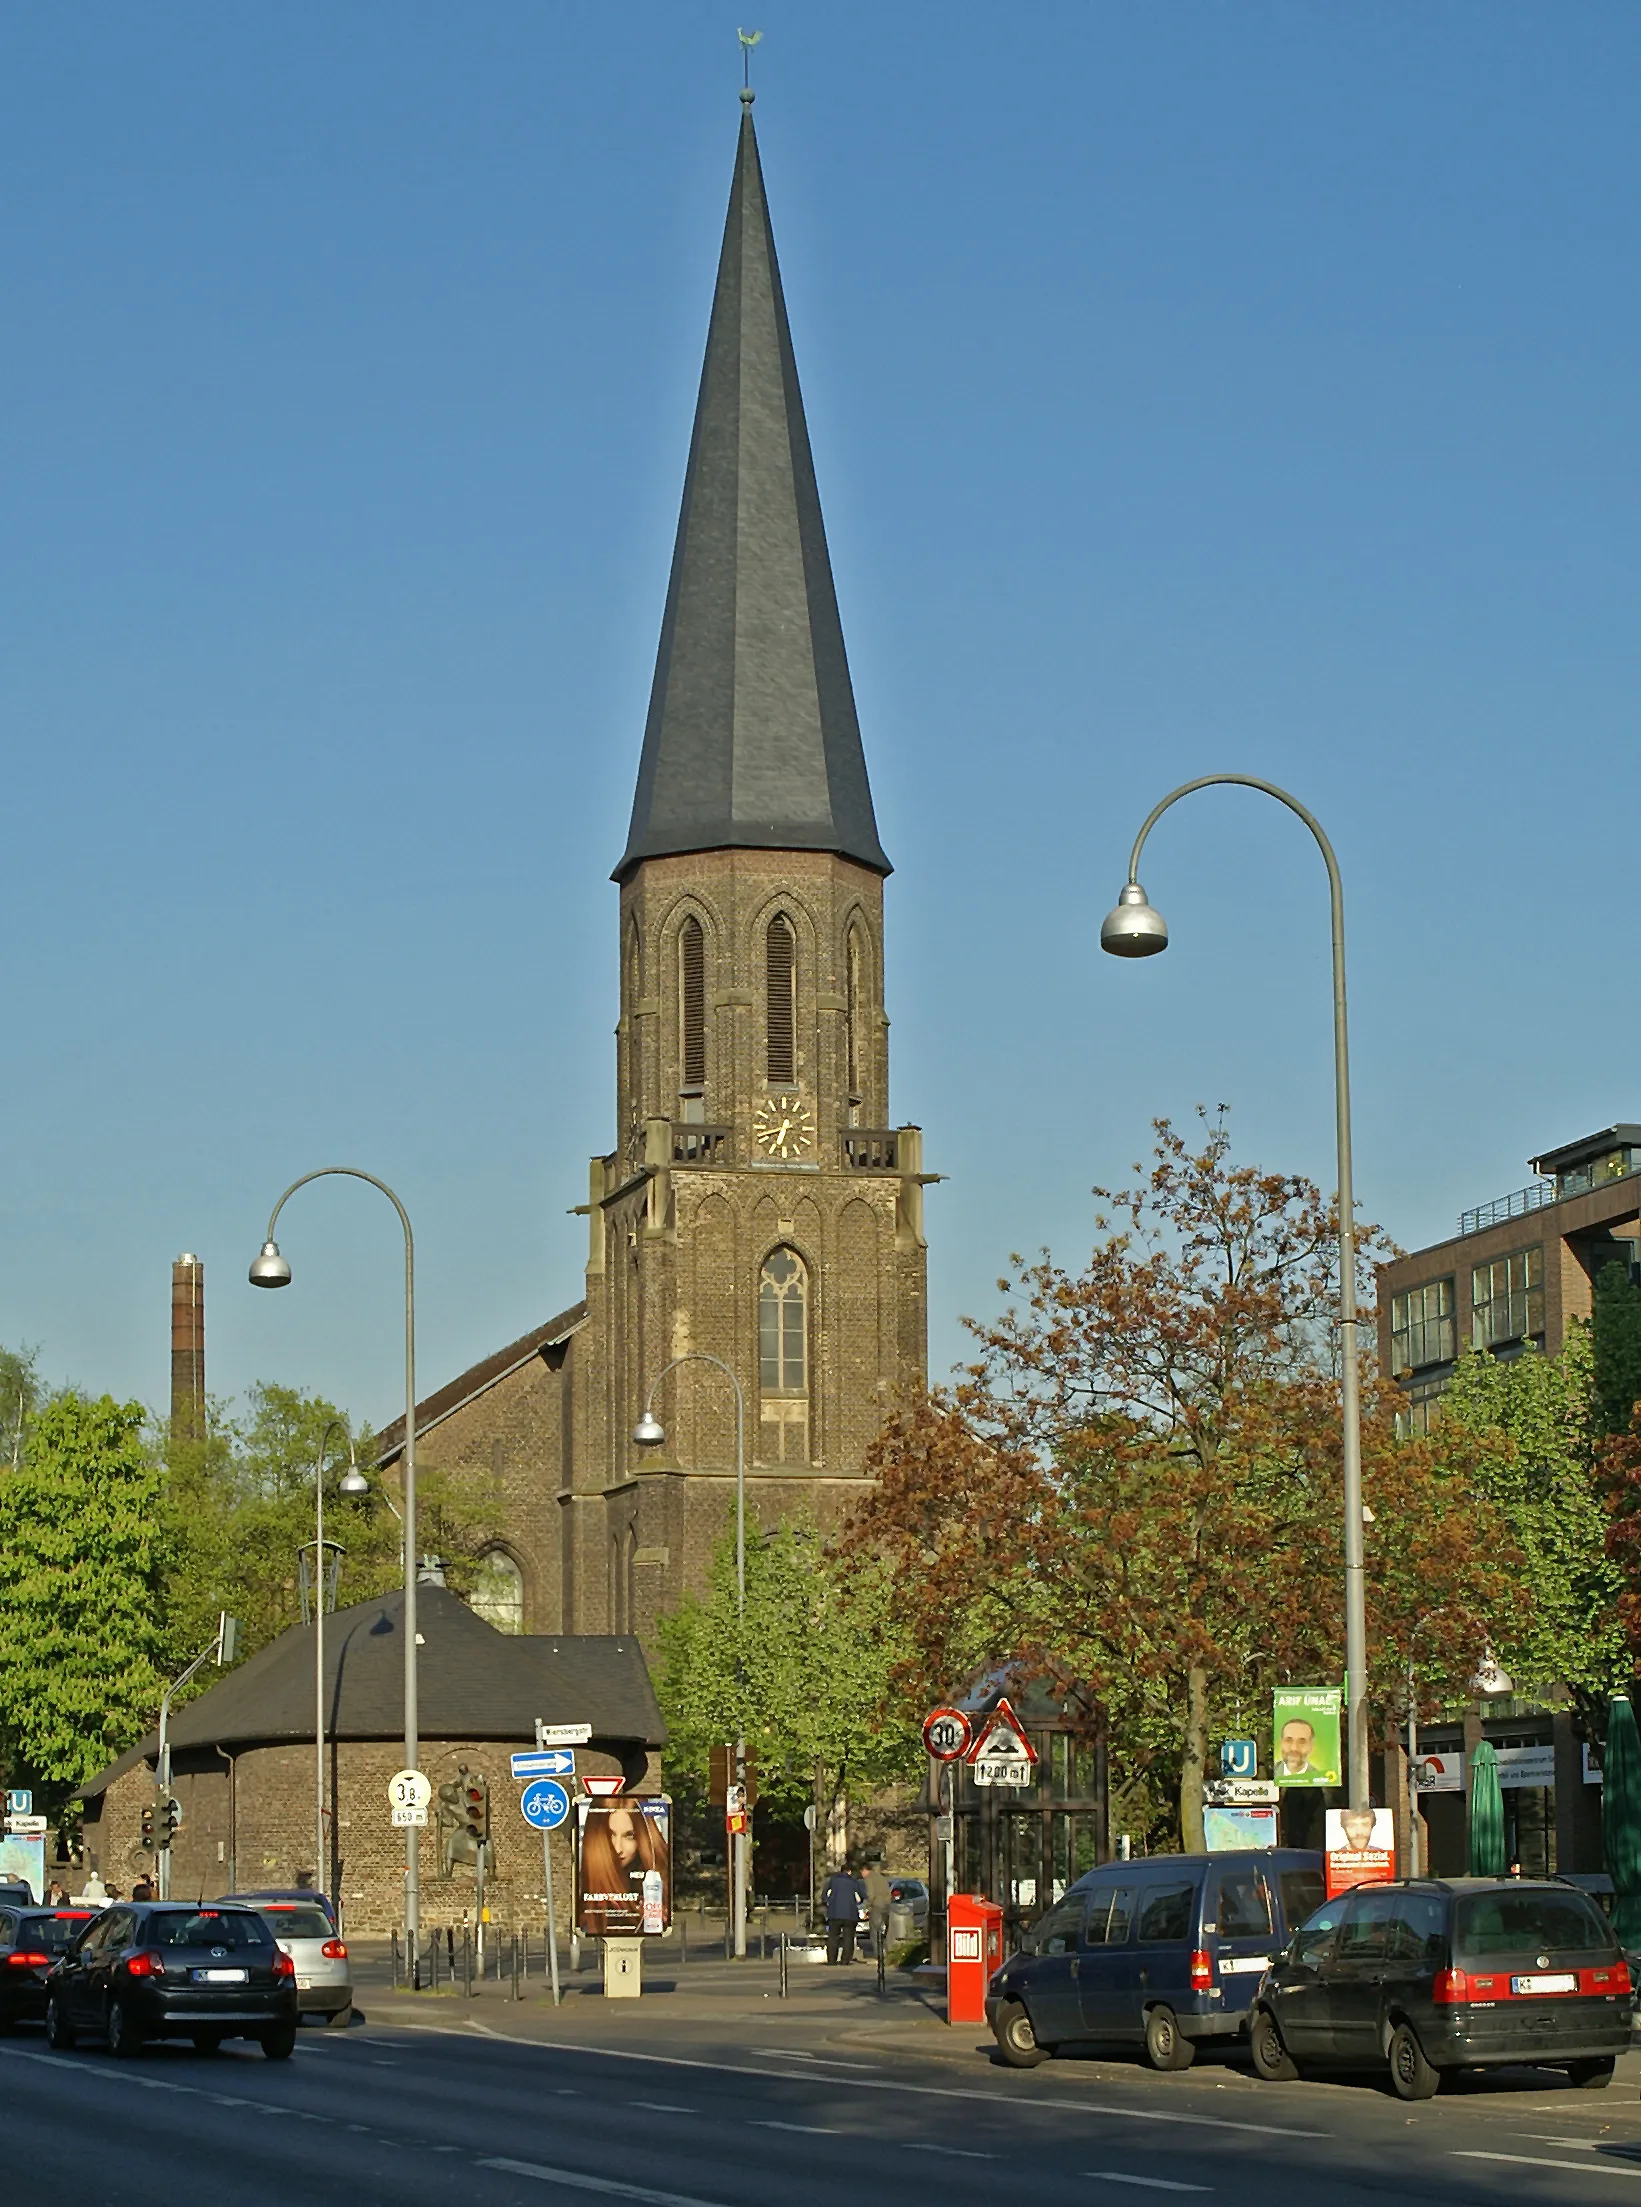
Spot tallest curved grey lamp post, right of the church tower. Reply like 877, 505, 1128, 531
1101, 775, 1368, 1808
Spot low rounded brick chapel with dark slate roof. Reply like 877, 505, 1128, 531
82, 1585, 664, 1931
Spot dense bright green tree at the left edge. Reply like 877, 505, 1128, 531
0, 1393, 170, 1790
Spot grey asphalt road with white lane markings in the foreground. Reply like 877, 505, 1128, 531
0, 2002, 1641, 2207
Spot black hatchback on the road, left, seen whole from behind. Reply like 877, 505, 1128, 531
46, 1900, 296, 2061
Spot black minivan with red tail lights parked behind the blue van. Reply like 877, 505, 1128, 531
1248, 1878, 1630, 2099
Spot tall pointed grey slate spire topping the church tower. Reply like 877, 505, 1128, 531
615, 90, 889, 881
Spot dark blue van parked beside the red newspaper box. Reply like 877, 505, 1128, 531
986, 1847, 1323, 2070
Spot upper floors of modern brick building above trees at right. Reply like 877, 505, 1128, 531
1379, 1126, 1641, 1432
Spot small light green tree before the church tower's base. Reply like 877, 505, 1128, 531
659, 1525, 920, 1812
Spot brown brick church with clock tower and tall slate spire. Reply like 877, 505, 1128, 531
377, 95, 926, 1640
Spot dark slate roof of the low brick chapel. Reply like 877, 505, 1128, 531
82, 1585, 666, 1796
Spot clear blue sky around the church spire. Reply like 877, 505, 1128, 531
0, 0, 1641, 1419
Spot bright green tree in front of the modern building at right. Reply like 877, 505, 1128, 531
1434, 1326, 1628, 1699
